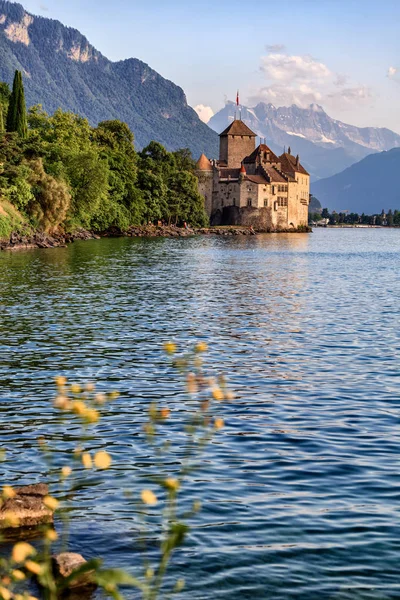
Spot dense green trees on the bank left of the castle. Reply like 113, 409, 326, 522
0, 71, 207, 238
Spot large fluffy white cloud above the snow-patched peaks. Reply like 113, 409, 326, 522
249, 45, 373, 108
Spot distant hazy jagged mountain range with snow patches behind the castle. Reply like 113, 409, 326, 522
208, 102, 400, 181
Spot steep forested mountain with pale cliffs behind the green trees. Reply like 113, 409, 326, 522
0, 0, 218, 157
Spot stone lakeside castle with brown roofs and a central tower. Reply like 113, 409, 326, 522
196, 119, 310, 231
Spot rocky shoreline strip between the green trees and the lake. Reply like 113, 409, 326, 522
0, 225, 312, 251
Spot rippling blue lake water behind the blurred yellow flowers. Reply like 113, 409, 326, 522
0, 229, 400, 600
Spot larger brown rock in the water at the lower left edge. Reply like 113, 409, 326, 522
0, 483, 53, 529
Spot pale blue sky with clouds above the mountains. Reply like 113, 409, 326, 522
22, 0, 400, 133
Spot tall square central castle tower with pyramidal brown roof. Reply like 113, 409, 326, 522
219, 119, 257, 169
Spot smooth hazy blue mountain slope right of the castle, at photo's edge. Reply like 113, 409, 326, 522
311, 148, 400, 215
